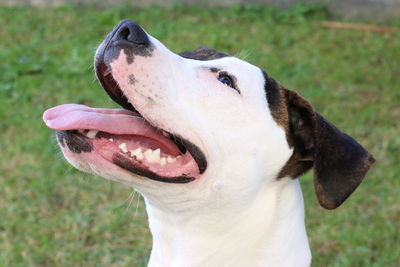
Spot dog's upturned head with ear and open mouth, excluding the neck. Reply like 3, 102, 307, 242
44, 21, 374, 209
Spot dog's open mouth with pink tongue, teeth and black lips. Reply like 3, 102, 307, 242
43, 59, 207, 183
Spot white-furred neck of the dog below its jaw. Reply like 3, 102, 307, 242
142, 180, 311, 267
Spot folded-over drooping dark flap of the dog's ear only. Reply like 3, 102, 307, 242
314, 113, 375, 209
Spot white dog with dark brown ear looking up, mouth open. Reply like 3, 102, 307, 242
43, 20, 375, 267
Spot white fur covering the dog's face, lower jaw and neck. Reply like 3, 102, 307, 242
58, 33, 311, 267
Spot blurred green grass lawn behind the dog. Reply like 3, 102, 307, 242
0, 6, 400, 266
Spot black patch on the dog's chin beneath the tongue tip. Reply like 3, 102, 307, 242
56, 131, 93, 154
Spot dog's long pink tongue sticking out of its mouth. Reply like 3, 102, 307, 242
43, 104, 162, 140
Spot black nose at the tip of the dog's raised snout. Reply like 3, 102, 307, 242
113, 20, 149, 46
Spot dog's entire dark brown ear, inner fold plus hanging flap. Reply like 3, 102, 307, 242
285, 90, 375, 209
